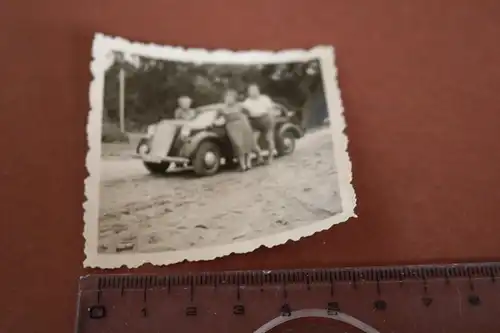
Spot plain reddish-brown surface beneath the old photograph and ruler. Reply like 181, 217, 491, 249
0, 0, 500, 333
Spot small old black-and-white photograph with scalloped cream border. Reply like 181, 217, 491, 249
85, 35, 355, 268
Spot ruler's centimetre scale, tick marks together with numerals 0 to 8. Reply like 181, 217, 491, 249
80, 263, 500, 318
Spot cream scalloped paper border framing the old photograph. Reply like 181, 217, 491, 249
83, 33, 357, 268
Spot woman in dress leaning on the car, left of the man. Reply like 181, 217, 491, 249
218, 89, 255, 171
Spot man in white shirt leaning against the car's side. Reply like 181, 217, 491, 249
242, 84, 275, 163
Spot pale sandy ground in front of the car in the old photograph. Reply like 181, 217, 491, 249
99, 129, 341, 252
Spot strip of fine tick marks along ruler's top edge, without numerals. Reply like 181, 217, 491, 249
80, 263, 500, 293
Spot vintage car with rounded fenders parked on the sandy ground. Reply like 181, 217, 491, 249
137, 103, 304, 176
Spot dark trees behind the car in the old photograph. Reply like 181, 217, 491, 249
104, 54, 322, 131
